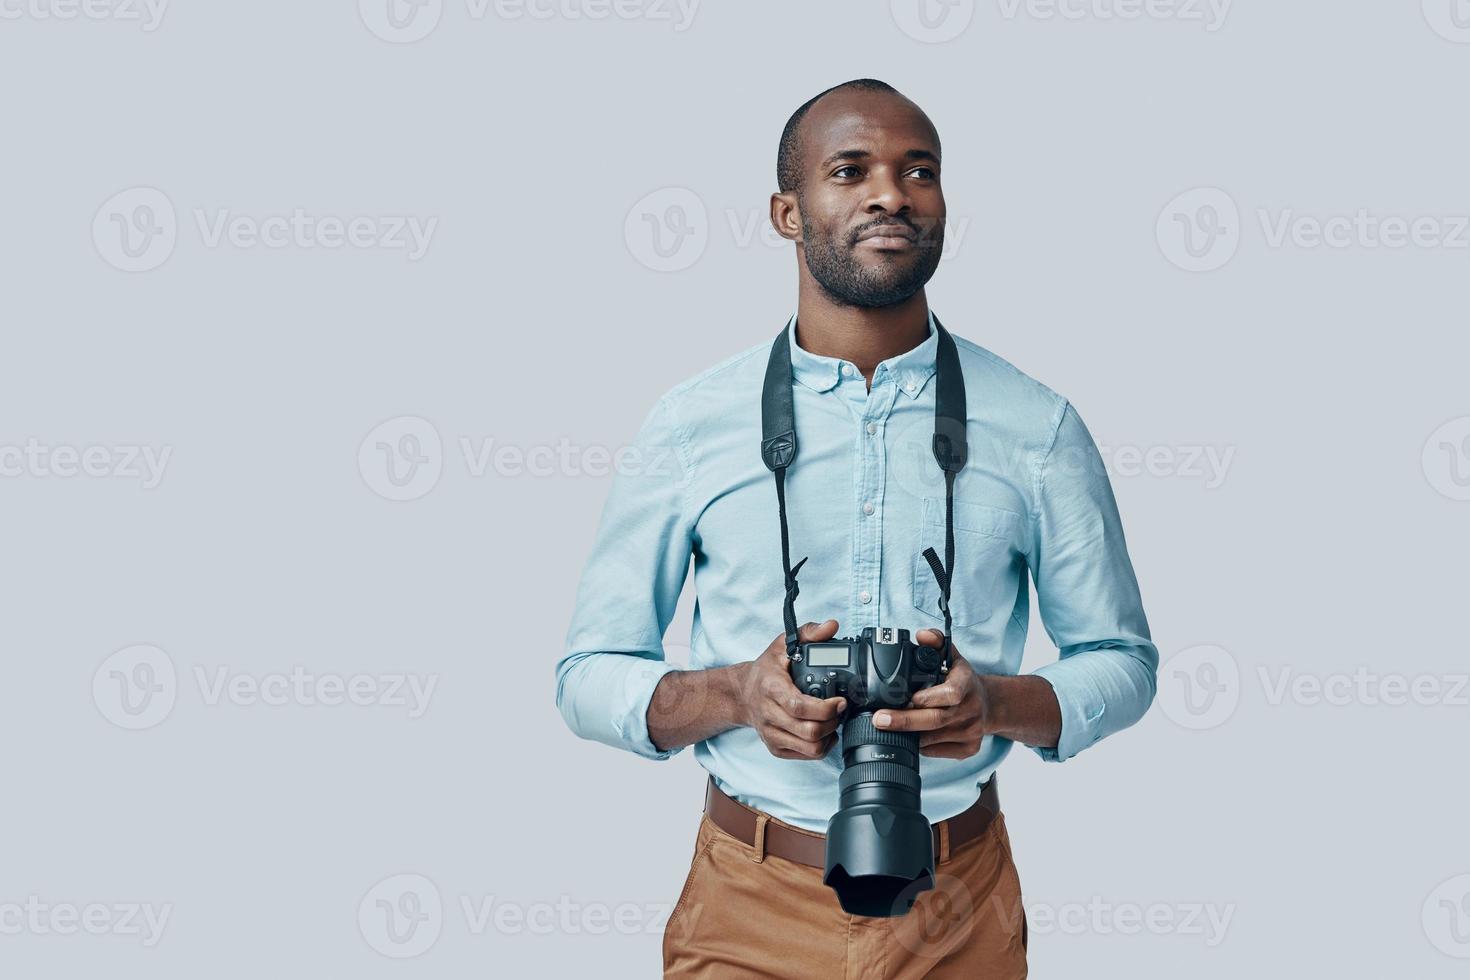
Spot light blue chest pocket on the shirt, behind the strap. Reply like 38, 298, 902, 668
913, 497, 1022, 629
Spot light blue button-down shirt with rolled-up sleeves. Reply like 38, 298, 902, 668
556, 314, 1158, 832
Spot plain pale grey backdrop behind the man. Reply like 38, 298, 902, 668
0, 0, 1470, 979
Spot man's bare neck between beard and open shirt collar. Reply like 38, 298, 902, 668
797, 284, 929, 388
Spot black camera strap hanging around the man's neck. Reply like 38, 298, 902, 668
760, 317, 969, 671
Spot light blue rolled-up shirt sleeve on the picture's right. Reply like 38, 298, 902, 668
1032, 404, 1158, 763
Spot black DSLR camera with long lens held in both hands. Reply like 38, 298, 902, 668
788, 626, 948, 917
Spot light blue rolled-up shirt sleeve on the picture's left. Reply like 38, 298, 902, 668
556, 395, 692, 760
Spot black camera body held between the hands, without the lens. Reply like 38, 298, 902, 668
789, 626, 945, 716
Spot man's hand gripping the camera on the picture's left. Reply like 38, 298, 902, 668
739, 620, 847, 758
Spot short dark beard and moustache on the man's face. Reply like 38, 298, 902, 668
801, 212, 944, 307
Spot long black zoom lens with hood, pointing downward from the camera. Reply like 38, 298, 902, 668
823, 711, 933, 917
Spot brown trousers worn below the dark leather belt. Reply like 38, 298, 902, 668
663, 815, 1026, 980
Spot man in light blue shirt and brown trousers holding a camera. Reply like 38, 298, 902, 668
557, 79, 1158, 980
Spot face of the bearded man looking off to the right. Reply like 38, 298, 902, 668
797, 91, 945, 307
